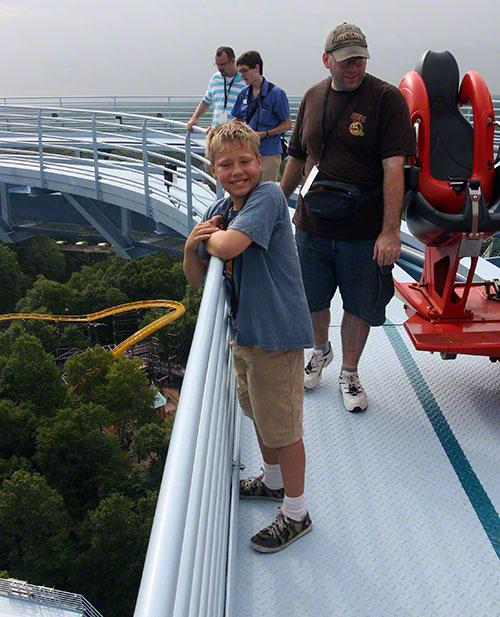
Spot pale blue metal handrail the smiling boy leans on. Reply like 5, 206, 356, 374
134, 258, 239, 617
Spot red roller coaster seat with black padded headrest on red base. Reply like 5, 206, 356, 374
395, 51, 500, 359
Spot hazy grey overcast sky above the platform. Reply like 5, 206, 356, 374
0, 0, 500, 96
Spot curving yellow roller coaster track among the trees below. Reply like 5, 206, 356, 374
0, 300, 186, 358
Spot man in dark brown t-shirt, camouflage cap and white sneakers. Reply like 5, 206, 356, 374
281, 23, 415, 412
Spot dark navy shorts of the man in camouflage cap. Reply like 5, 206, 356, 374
295, 229, 394, 326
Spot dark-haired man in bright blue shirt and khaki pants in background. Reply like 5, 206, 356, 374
231, 51, 292, 182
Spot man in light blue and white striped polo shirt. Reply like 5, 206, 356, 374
188, 47, 245, 131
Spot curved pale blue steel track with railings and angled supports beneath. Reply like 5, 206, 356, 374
0, 106, 215, 258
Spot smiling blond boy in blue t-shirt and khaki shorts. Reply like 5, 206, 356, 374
184, 120, 313, 553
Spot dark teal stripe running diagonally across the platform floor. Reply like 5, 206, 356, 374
384, 321, 500, 559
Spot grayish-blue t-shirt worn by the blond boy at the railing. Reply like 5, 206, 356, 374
199, 182, 313, 350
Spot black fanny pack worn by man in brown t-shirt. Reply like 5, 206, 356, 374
304, 180, 382, 221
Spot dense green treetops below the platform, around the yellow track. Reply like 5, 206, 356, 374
0, 236, 200, 617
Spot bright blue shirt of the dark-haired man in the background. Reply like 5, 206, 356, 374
231, 78, 290, 156
